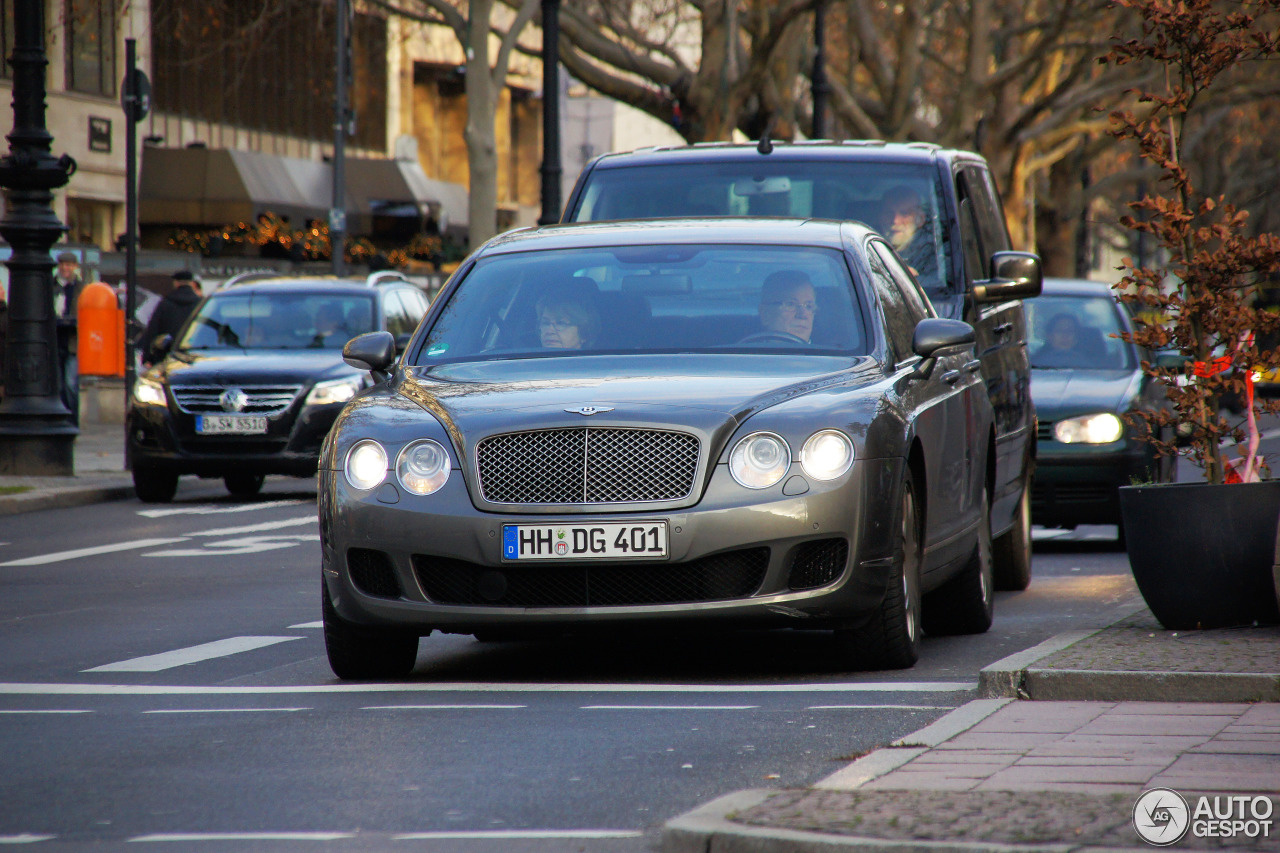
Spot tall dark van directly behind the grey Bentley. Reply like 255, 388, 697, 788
563, 141, 1041, 589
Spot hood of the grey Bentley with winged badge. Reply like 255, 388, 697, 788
399, 355, 874, 434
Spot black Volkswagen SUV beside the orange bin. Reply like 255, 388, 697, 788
127, 273, 428, 502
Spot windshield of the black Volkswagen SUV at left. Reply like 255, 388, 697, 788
178, 288, 374, 350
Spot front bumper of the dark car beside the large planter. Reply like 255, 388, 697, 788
1032, 439, 1160, 528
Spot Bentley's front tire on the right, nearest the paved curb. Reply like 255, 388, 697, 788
835, 478, 920, 670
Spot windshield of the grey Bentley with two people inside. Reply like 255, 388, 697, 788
416, 245, 868, 364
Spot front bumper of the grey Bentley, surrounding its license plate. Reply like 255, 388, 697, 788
319, 460, 904, 634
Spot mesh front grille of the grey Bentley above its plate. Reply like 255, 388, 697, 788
476, 427, 698, 503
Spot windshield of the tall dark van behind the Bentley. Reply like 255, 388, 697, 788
571, 158, 951, 293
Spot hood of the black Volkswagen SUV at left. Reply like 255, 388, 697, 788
160, 350, 356, 386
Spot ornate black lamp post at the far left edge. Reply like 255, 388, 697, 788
0, 0, 79, 476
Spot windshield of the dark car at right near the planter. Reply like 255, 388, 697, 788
1023, 293, 1137, 370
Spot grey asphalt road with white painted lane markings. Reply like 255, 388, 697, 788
0, 479, 1139, 853
